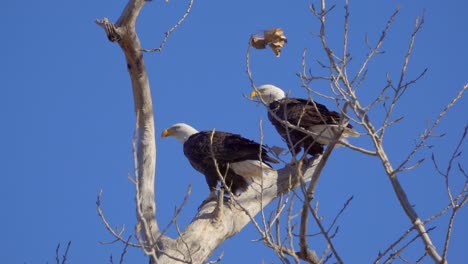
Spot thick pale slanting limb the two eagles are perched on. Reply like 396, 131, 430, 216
158, 156, 321, 263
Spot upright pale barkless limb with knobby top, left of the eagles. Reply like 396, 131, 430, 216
96, 0, 163, 258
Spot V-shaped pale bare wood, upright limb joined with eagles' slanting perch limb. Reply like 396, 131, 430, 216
96, 0, 320, 263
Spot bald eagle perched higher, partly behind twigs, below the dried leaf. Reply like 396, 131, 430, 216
250, 84, 359, 156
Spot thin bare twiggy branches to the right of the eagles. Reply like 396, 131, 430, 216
247, 0, 468, 263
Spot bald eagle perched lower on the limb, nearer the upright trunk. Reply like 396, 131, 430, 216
161, 123, 278, 197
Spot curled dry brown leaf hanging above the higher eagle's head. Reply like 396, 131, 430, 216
250, 28, 288, 57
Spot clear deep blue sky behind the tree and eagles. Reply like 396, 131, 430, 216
0, 0, 468, 264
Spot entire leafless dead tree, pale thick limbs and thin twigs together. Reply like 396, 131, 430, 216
96, 0, 468, 263
